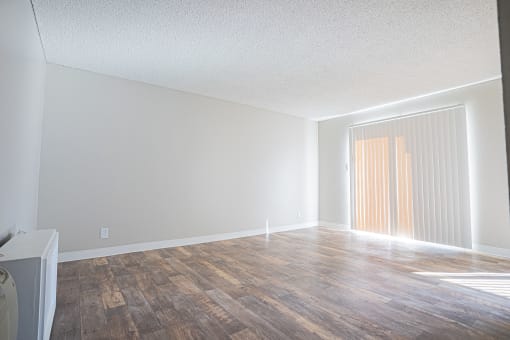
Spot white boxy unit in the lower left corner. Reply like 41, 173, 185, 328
0, 229, 58, 340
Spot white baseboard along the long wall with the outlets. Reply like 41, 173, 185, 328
58, 221, 319, 262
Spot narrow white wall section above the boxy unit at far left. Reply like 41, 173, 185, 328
0, 0, 46, 240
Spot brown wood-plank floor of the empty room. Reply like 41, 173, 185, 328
52, 228, 510, 339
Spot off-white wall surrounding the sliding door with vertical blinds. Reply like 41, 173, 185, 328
319, 80, 510, 254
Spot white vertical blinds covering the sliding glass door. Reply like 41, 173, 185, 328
350, 106, 471, 248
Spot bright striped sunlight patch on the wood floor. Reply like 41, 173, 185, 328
415, 272, 510, 298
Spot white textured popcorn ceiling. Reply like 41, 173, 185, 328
33, 0, 500, 119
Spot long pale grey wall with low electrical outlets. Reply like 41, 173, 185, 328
39, 64, 318, 251
